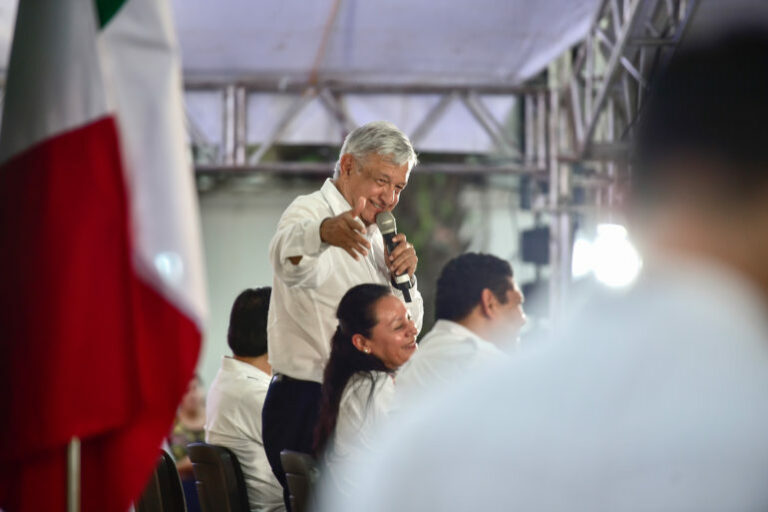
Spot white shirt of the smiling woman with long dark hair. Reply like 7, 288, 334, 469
325, 372, 395, 494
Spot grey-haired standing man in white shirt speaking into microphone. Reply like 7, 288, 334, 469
262, 121, 424, 506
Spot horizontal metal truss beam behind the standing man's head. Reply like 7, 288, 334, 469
185, 78, 550, 179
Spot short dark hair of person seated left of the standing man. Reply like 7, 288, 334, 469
227, 286, 272, 357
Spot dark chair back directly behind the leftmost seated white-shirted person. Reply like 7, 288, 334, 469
187, 443, 250, 512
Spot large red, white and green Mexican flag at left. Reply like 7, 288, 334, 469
0, 0, 206, 512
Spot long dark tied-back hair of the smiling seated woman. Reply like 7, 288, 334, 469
313, 284, 392, 457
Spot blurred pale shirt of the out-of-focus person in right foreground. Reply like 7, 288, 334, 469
325, 261, 768, 512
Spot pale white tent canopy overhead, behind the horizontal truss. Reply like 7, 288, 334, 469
0, 0, 599, 153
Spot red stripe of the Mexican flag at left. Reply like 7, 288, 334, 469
0, 118, 200, 512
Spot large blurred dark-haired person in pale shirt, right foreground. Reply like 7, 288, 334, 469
325, 28, 768, 512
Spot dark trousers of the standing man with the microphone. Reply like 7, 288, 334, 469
261, 374, 320, 511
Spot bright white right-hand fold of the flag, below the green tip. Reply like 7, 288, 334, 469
100, 0, 207, 330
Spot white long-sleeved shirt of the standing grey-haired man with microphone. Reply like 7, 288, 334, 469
267, 179, 424, 383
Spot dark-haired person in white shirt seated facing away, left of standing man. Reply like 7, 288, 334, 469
205, 287, 285, 512
